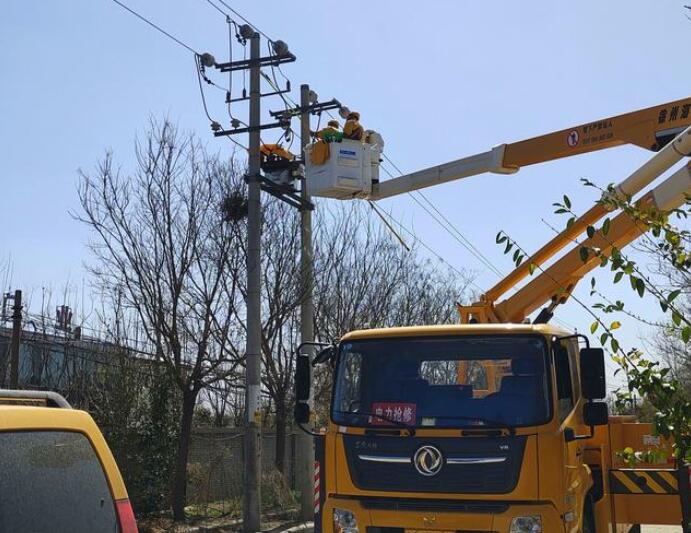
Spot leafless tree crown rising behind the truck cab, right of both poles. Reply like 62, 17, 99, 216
314, 206, 472, 422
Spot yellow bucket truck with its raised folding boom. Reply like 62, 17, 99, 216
295, 99, 691, 533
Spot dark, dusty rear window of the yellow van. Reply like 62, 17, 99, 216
0, 431, 119, 533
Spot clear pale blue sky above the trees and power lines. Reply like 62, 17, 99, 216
0, 0, 691, 386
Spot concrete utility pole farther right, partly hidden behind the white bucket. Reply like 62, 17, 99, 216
295, 85, 314, 520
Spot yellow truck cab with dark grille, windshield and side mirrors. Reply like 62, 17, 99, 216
296, 324, 664, 533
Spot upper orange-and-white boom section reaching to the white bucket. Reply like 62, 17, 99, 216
369, 98, 691, 200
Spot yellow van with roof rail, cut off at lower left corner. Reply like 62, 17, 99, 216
0, 390, 138, 533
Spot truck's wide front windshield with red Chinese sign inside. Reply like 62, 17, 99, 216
332, 335, 550, 427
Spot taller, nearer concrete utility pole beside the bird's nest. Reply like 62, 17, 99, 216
243, 32, 262, 533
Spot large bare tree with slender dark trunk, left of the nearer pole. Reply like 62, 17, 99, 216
75, 120, 241, 520
